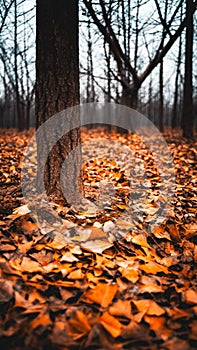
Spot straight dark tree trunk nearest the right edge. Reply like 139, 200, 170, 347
182, 0, 194, 138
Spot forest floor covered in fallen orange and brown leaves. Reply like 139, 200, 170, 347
0, 129, 197, 350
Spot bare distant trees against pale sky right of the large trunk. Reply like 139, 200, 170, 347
81, 0, 197, 137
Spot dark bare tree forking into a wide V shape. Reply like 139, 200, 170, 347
83, 0, 196, 115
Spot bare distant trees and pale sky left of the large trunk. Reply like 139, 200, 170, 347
0, 0, 35, 130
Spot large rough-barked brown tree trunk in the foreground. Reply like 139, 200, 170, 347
35, 0, 82, 202
